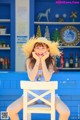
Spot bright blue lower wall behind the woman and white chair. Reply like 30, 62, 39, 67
0, 72, 80, 120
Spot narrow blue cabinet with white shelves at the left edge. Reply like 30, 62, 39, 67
0, 0, 15, 71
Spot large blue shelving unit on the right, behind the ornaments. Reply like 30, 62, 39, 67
33, 0, 80, 71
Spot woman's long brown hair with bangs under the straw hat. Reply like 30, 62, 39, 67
26, 42, 57, 72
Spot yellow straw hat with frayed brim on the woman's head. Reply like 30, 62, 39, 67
22, 37, 61, 57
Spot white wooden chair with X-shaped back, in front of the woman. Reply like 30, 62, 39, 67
20, 80, 58, 120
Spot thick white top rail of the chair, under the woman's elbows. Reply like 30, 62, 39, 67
20, 80, 58, 90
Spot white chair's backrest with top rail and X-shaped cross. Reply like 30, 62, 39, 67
20, 80, 58, 105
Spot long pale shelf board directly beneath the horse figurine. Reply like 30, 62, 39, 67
34, 21, 80, 25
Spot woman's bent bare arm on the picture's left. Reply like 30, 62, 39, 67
26, 59, 40, 82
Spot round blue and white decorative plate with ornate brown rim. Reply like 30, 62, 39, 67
60, 26, 80, 46
